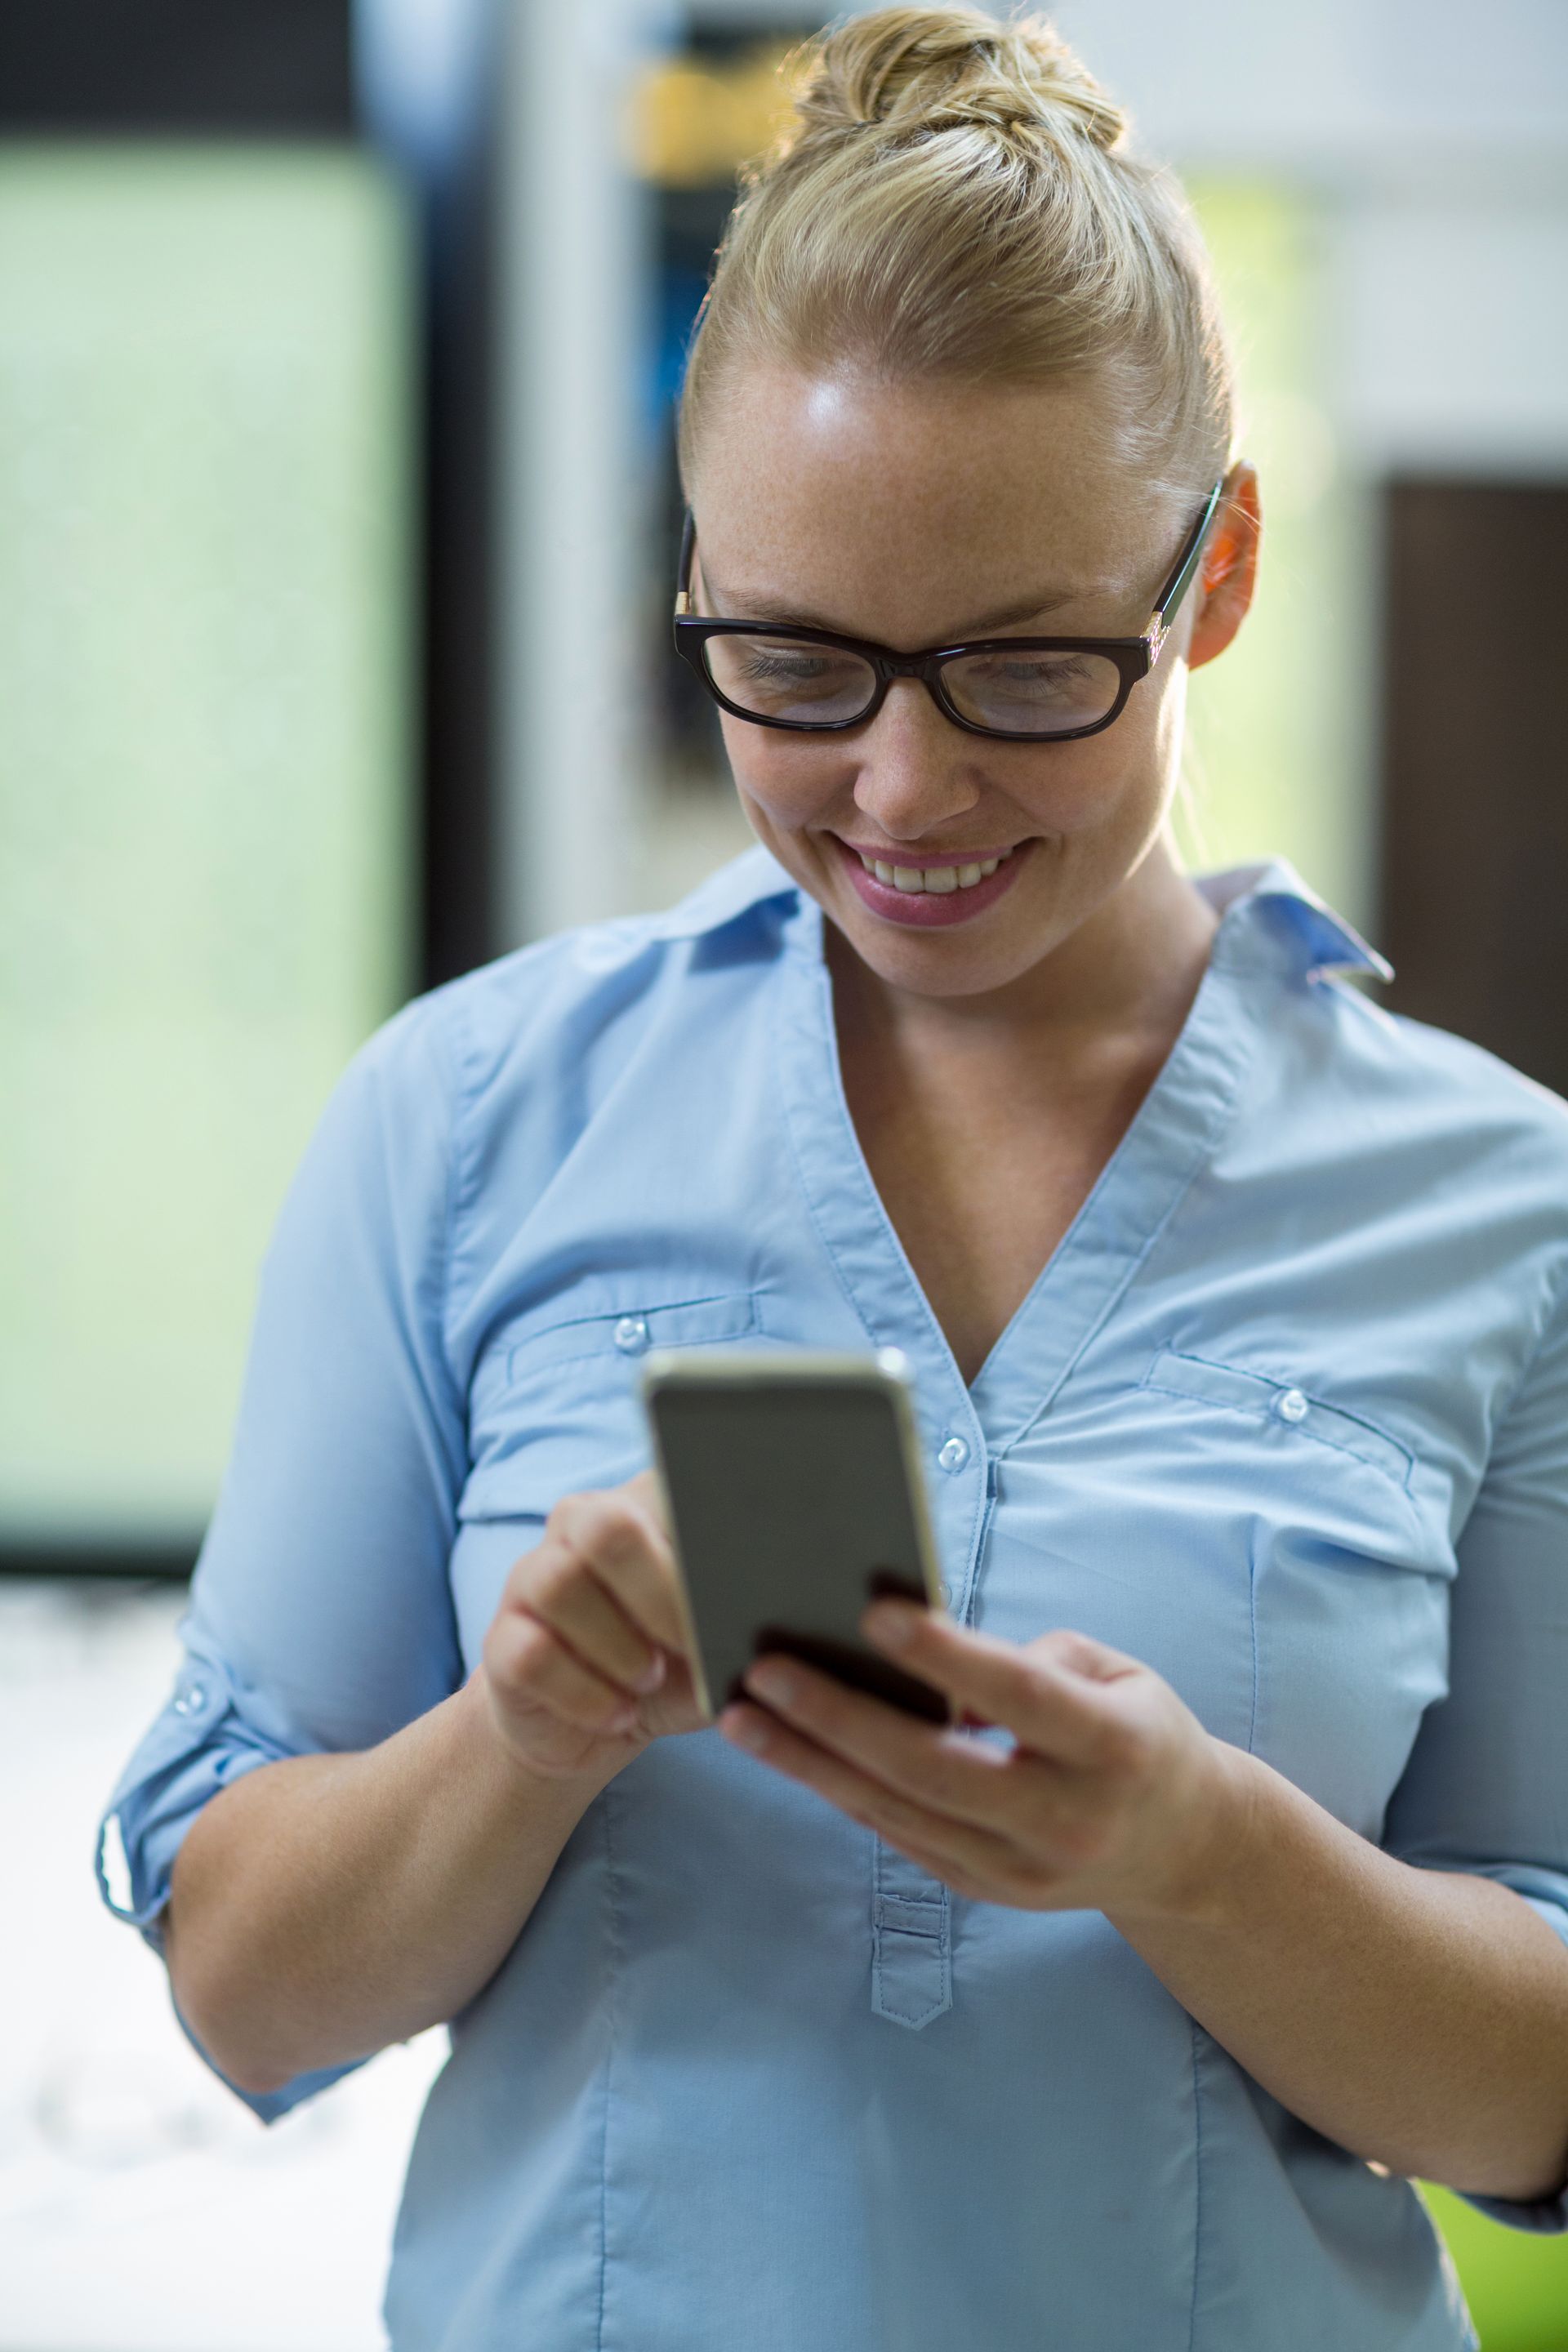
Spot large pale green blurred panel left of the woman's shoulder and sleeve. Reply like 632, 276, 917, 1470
0, 144, 414, 1543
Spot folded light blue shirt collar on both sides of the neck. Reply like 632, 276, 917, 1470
648, 842, 1394, 981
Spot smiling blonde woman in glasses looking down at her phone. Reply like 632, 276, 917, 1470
95, 10, 1568, 2352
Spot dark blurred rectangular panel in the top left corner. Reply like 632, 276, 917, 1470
0, 0, 355, 136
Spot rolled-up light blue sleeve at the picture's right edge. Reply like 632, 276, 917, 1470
1384, 1291, 1568, 2232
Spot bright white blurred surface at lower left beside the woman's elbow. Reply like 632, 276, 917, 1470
0, 1578, 447, 2352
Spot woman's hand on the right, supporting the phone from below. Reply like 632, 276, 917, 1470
719, 1601, 1246, 1917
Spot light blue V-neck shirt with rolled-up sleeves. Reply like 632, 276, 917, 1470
99, 849, 1568, 2352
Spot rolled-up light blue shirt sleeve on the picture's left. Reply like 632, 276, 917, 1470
94, 990, 466, 2122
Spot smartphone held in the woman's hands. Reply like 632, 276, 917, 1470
642, 1348, 952, 1724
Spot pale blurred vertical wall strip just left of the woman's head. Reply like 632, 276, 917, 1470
498, 0, 675, 941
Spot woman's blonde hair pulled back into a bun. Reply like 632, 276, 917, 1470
679, 7, 1236, 499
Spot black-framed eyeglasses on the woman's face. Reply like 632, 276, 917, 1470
675, 478, 1225, 743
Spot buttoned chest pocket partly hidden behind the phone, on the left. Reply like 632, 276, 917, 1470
458, 1284, 764, 1519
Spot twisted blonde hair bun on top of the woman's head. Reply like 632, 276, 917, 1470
792, 7, 1126, 153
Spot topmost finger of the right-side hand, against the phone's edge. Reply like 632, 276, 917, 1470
861, 1599, 1135, 1771
